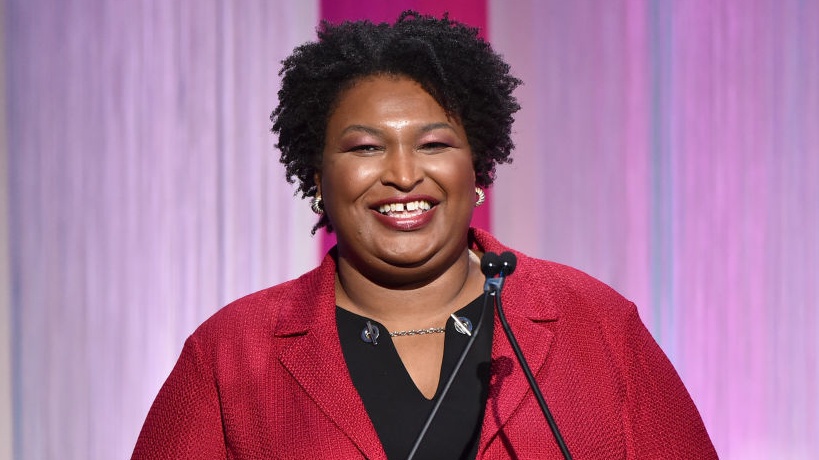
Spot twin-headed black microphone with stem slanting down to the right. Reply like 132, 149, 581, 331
490, 251, 572, 460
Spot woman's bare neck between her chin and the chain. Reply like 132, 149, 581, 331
336, 248, 483, 331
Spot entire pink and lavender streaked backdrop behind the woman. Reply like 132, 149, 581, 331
0, 0, 819, 459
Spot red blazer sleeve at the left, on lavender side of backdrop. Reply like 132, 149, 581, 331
131, 336, 227, 460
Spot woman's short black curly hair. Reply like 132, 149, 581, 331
270, 11, 521, 233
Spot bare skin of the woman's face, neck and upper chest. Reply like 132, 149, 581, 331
316, 75, 483, 406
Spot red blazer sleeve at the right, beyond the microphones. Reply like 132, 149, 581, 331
623, 305, 717, 459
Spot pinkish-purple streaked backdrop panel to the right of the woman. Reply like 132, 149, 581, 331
489, 0, 819, 460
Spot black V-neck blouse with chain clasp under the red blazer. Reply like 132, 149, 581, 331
336, 295, 493, 459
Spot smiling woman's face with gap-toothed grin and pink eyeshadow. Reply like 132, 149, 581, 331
316, 76, 475, 281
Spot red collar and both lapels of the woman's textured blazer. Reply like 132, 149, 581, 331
274, 229, 559, 459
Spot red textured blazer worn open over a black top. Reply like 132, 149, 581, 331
132, 230, 717, 460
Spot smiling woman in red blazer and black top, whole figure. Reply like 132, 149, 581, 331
133, 12, 716, 459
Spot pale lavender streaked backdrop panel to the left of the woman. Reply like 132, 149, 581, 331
6, 0, 319, 459
